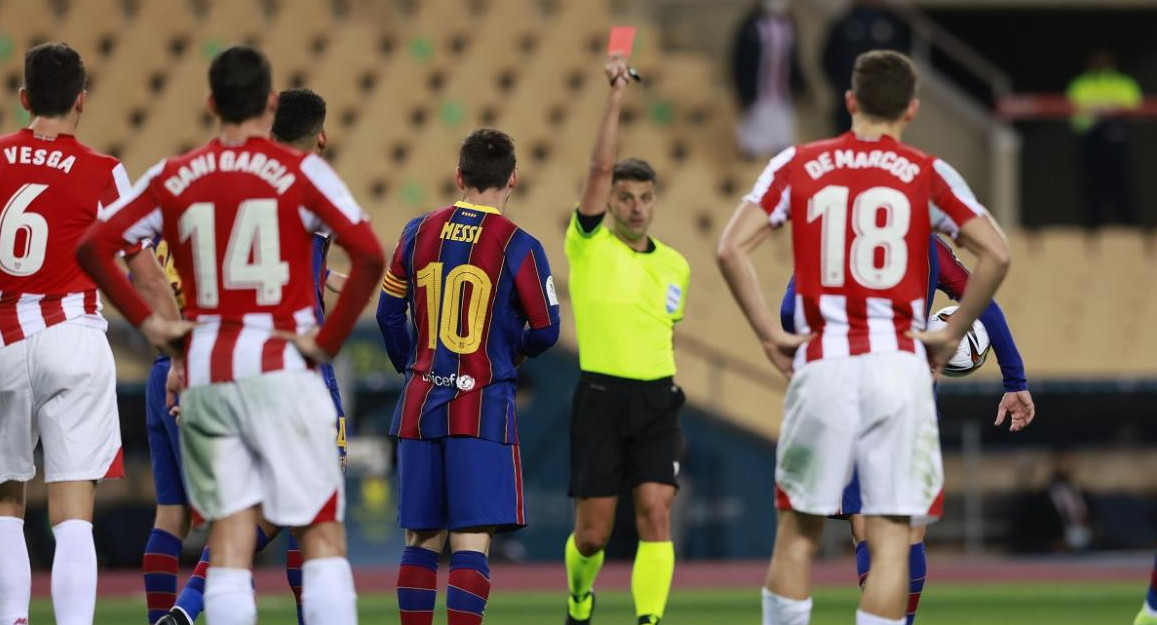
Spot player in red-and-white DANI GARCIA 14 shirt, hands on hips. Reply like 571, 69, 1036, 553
78, 46, 384, 625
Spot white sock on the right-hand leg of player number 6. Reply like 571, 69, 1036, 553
52, 519, 96, 625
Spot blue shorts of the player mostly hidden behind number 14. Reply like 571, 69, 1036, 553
145, 356, 189, 506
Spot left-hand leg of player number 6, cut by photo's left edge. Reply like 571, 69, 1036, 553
0, 481, 32, 623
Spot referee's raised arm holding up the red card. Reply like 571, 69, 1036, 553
579, 56, 631, 219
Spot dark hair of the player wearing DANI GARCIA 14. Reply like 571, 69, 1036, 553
209, 45, 273, 124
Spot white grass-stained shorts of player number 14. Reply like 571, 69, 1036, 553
180, 372, 345, 527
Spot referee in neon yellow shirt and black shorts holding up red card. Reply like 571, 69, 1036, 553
566, 57, 691, 625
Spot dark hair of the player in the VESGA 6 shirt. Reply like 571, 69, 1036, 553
24, 43, 86, 117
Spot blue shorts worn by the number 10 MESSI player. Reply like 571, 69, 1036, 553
398, 436, 526, 532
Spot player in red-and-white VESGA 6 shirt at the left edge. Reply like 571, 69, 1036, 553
0, 43, 177, 625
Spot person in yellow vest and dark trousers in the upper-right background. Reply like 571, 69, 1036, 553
1066, 50, 1142, 228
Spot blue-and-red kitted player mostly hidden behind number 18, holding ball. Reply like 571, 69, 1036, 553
780, 235, 1036, 625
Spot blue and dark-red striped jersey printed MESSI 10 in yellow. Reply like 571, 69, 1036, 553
382, 201, 559, 443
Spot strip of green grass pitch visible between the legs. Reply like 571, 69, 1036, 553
31, 580, 1144, 625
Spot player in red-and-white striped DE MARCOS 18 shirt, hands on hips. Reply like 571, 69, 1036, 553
718, 51, 1010, 625
